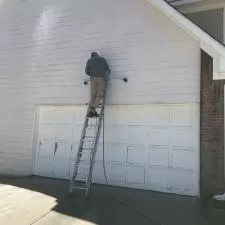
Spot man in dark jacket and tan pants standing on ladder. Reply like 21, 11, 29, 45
85, 52, 110, 117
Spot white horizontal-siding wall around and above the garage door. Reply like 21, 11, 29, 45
0, 0, 200, 174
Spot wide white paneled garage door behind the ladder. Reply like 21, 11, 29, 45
35, 104, 199, 195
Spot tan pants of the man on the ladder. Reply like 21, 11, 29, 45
89, 77, 105, 112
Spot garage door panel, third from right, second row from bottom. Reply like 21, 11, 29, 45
127, 145, 148, 164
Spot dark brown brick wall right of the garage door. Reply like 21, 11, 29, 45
200, 51, 224, 196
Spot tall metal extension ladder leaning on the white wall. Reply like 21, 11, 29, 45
69, 76, 108, 198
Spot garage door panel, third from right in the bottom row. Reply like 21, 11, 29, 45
126, 166, 145, 185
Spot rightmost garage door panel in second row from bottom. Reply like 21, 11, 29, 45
171, 150, 197, 170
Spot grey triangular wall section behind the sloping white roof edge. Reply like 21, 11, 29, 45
187, 8, 224, 43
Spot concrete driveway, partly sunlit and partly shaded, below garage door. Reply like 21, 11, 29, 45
0, 177, 225, 225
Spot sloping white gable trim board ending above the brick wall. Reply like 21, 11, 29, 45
147, 0, 225, 79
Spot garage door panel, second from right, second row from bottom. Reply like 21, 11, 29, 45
148, 147, 169, 167
